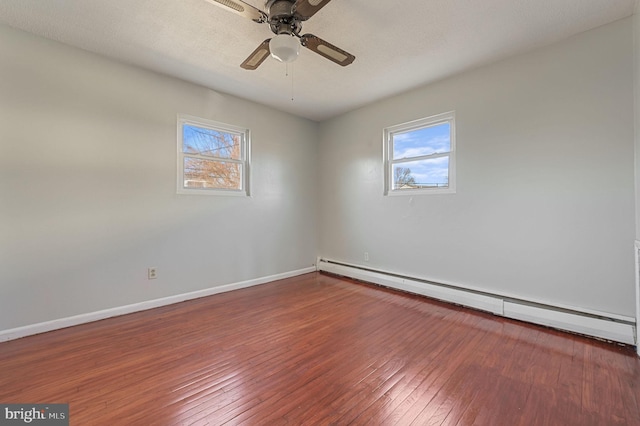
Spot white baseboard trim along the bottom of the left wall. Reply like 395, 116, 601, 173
0, 266, 317, 342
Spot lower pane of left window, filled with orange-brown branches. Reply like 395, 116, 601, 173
184, 157, 242, 190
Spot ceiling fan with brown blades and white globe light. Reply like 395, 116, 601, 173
206, 0, 356, 70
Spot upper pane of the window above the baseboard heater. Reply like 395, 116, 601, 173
393, 122, 451, 160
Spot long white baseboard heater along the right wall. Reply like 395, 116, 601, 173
317, 258, 636, 345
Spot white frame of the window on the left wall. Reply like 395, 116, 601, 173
177, 114, 251, 197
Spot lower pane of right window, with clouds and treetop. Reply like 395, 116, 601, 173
393, 155, 449, 189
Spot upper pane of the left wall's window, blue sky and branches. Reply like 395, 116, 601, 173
182, 124, 242, 161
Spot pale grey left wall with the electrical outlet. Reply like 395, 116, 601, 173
0, 27, 317, 330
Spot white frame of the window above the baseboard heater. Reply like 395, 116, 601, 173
383, 111, 456, 196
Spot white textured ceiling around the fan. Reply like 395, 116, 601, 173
0, 0, 636, 121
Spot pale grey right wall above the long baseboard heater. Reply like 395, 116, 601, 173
319, 19, 635, 316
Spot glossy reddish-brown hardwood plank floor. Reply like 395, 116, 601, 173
0, 273, 640, 425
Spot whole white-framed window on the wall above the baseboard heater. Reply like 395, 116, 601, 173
384, 112, 455, 195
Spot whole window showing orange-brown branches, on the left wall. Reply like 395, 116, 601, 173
178, 115, 250, 195
